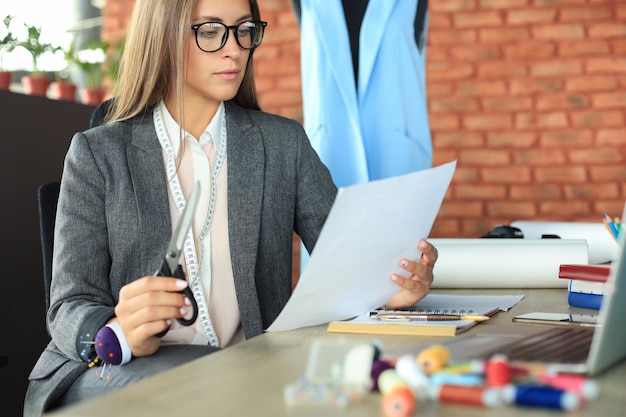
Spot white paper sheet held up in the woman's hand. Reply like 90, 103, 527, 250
267, 161, 456, 331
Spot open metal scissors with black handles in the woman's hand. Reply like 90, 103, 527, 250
154, 182, 200, 337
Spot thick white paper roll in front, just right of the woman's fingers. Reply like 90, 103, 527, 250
428, 238, 588, 288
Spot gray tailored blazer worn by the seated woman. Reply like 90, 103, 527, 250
24, 103, 337, 415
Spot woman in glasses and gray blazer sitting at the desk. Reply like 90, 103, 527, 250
24, 0, 437, 416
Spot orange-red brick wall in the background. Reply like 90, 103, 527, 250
103, 0, 626, 245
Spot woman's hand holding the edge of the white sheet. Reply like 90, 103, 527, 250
385, 240, 438, 309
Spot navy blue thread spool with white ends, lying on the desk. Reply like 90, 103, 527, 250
502, 384, 580, 411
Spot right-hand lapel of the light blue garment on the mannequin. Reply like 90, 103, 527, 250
358, 0, 406, 101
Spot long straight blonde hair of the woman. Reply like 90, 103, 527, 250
105, 0, 261, 122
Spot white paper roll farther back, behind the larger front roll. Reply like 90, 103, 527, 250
511, 221, 619, 264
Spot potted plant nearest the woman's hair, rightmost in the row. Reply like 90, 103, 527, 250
74, 38, 107, 106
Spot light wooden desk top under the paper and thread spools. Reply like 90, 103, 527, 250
45, 289, 626, 417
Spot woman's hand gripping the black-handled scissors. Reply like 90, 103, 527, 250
111, 276, 190, 357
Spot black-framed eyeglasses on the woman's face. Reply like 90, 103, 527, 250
191, 21, 267, 52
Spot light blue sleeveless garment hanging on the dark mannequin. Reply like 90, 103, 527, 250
300, 0, 432, 187
